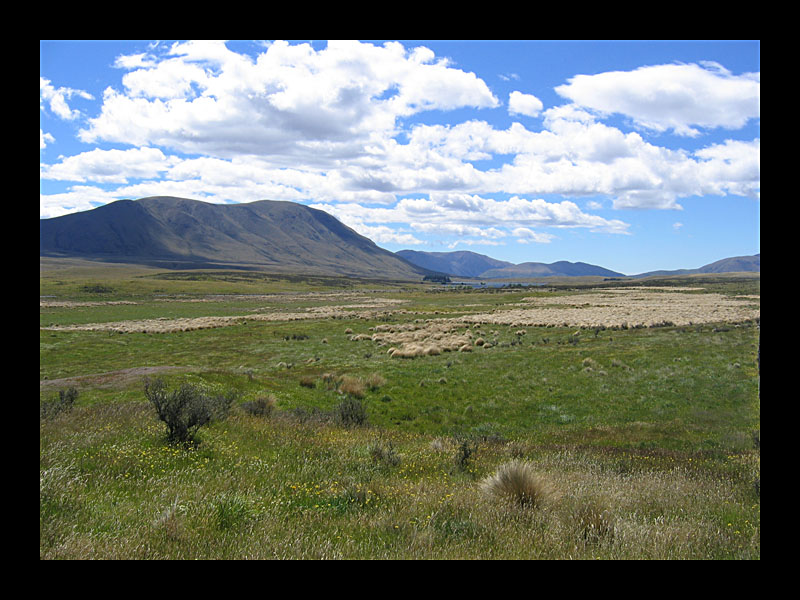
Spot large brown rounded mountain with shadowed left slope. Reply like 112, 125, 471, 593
39, 196, 429, 281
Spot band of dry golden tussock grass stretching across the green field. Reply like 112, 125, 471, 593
42, 288, 760, 332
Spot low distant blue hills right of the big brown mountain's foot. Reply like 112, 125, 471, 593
397, 250, 625, 279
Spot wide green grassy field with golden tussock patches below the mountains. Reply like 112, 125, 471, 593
39, 261, 760, 559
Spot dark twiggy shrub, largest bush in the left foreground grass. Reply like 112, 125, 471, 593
144, 379, 234, 444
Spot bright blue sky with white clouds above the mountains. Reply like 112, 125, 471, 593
39, 40, 761, 275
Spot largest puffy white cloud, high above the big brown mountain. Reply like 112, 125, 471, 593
81, 41, 498, 164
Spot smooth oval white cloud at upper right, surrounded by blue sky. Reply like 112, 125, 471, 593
555, 63, 761, 137
